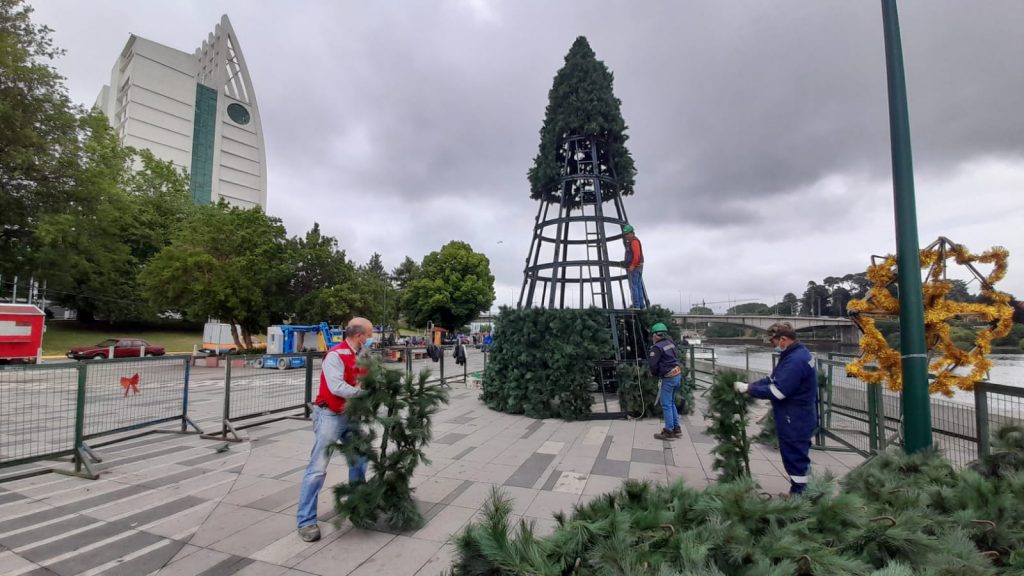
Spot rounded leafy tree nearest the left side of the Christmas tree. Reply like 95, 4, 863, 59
402, 241, 495, 330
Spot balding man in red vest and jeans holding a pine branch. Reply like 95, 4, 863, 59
297, 318, 374, 542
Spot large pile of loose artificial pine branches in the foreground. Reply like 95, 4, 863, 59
452, 424, 1024, 576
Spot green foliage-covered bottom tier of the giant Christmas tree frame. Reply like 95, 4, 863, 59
480, 306, 692, 420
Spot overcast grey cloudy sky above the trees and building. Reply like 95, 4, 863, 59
25, 0, 1024, 311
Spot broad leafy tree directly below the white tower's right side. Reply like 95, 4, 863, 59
141, 201, 292, 347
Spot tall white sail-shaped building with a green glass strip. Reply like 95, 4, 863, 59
95, 15, 266, 207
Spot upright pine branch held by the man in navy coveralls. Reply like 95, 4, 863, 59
708, 370, 754, 482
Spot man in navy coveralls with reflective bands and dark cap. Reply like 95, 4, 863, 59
735, 322, 818, 494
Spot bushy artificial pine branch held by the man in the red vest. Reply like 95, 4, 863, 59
333, 360, 447, 531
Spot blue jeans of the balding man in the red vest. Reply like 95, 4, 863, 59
296, 407, 367, 528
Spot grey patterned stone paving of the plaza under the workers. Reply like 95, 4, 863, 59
0, 354, 860, 576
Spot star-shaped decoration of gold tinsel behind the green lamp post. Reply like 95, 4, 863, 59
847, 237, 1013, 397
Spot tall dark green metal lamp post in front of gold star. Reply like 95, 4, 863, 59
882, 0, 932, 453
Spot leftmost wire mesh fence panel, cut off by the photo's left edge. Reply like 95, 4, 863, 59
0, 364, 78, 466
